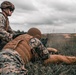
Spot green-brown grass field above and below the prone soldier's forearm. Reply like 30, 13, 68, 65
26, 34, 76, 75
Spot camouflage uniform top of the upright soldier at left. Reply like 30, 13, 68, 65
0, 13, 14, 41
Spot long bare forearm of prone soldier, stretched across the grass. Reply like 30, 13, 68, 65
44, 54, 76, 64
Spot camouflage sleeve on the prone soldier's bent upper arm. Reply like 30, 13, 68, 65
30, 38, 49, 60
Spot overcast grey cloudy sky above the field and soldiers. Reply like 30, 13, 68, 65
0, 0, 76, 33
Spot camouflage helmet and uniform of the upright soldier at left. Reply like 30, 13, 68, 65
0, 1, 15, 41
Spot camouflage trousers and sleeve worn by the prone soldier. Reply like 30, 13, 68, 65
0, 38, 49, 75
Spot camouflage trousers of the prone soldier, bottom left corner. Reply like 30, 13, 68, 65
0, 49, 27, 75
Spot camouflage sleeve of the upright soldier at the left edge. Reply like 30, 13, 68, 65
0, 14, 12, 41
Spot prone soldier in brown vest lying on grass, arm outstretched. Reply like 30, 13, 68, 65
0, 28, 76, 75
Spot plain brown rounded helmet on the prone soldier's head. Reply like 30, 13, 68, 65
27, 28, 42, 39
